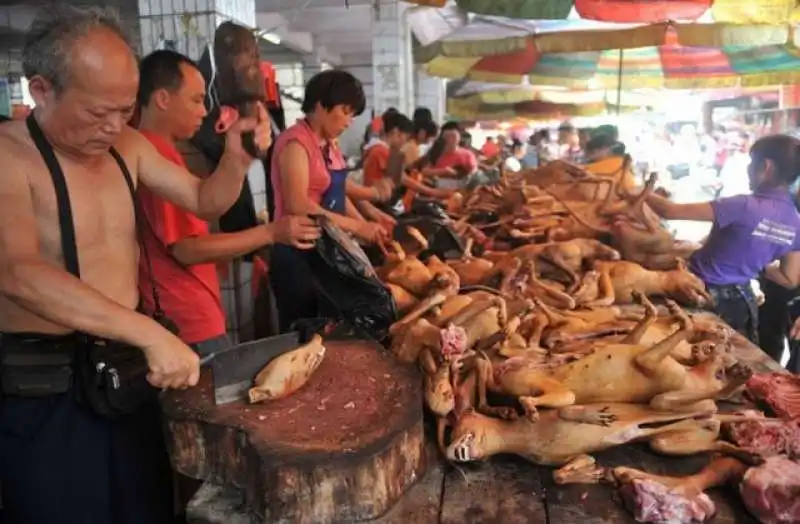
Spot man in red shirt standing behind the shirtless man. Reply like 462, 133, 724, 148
138, 50, 319, 355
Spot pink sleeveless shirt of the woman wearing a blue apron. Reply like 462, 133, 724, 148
271, 118, 344, 220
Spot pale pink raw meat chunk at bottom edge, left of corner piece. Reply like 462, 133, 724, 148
619, 479, 717, 524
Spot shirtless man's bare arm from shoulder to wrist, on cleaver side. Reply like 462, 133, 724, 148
0, 147, 166, 348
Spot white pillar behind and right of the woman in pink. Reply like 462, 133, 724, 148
372, 2, 414, 114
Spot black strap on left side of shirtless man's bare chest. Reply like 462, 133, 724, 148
26, 113, 81, 278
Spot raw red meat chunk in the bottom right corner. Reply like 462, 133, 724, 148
739, 456, 800, 524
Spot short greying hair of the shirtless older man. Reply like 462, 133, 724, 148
22, 2, 134, 92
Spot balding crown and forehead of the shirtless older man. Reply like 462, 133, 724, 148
22, 4, 136, 92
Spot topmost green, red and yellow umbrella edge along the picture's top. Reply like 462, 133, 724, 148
407, 0, 798, 24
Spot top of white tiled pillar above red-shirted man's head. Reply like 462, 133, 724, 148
138, 0, 256, 60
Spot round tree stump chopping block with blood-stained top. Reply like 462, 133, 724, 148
162, 341, 427, 524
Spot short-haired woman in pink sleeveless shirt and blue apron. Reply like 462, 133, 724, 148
269, 70, 383, 332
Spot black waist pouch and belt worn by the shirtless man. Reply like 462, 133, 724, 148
0, 334, 158, 419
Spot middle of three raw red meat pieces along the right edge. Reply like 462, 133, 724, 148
725, 418, 800, 457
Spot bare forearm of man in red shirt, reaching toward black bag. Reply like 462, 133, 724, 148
171, 224, 274, 266
